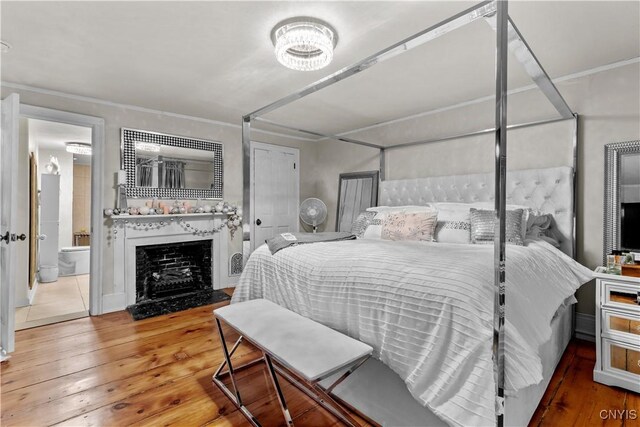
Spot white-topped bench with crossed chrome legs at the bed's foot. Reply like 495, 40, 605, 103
213, 299, 373, 427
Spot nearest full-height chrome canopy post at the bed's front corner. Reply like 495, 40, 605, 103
493, 0, 509, 427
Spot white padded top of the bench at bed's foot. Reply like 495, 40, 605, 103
214, 299, 373, 381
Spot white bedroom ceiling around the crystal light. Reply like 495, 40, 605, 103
0, 1, 640, 133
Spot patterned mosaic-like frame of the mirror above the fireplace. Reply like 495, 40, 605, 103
120, 128, 224, 199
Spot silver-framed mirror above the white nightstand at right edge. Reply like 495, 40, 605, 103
604, 141, 640, 258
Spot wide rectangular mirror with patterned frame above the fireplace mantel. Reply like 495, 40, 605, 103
121, 128, 223, 199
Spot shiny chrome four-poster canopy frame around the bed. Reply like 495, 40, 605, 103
242, 0, 578, 426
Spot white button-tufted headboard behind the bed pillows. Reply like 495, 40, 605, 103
378, 166, 574, 257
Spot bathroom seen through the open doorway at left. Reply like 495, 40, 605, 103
15, 118, 91, 330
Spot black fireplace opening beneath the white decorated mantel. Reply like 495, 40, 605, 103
136, 240, 213, 303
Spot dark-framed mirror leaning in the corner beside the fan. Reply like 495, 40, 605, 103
336, 171, 379, 231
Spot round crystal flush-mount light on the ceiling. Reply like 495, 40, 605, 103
271, 17, 338, 71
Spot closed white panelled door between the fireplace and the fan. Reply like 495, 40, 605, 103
250, 142, 300, 252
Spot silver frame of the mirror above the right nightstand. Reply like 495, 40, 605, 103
603, 141, 640, 263
